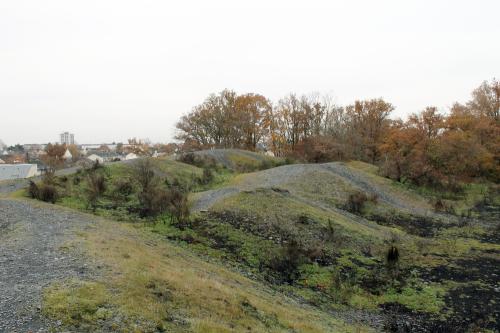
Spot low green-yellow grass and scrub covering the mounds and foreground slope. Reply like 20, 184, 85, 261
29, 150, 500, 332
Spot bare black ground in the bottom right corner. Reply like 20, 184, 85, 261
394, 256, 500, 332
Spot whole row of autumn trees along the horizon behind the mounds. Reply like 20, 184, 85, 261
176, 79, 500, 186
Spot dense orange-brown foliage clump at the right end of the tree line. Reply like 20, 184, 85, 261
379, 80, 500, 185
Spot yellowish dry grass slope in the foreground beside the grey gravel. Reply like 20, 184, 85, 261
43, 217, 366, 333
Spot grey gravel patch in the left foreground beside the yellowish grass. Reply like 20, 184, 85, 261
0, 199, 93, 333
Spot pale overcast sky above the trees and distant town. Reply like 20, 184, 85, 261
0, 0, 500, 144
